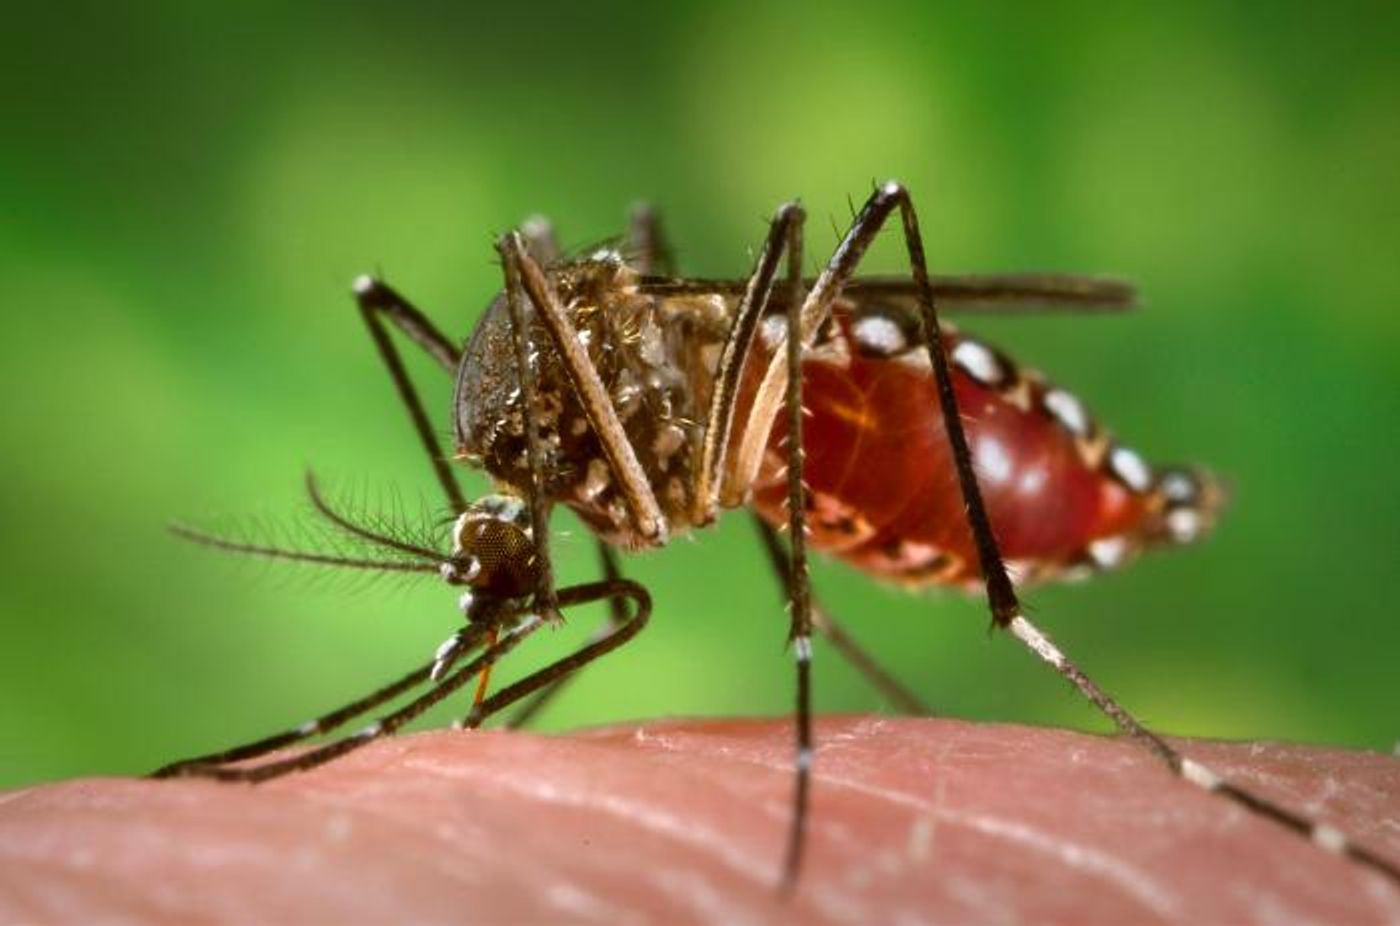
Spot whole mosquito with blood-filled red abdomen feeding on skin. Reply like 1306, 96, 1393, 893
155, 182, 1400, 890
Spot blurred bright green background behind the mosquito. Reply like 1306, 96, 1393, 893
0, 1, 1400, 785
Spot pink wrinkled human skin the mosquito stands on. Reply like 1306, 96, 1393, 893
0, 717, 1400, 923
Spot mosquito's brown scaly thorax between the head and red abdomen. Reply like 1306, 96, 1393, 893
454, 251, 734, 546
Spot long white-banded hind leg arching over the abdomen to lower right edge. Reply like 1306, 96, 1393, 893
806, 182, 1400, 884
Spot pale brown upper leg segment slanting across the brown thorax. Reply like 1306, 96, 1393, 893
498, 233, 666, 555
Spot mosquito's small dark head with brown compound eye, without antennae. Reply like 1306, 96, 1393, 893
442, 495, 539, 600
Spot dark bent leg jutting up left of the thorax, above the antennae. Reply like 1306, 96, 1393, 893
354, 276, 466, 514
